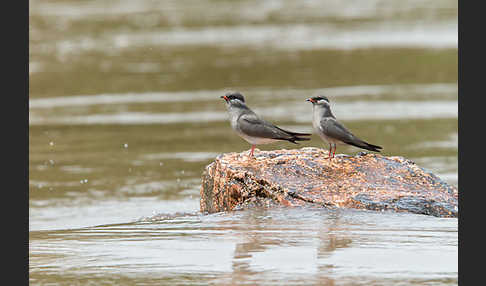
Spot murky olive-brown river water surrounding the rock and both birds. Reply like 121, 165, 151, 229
29, 0, 458, 285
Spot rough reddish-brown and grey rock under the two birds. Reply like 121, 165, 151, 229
200, 147, 458, 217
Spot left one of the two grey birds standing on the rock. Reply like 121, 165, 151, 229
221, 92, 311, 157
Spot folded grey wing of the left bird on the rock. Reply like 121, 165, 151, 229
238, 114, 292, 139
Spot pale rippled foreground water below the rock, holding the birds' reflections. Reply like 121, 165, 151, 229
30, 209, 457, 285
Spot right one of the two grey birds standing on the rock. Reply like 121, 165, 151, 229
306, 96, 383, 159
